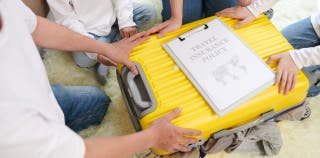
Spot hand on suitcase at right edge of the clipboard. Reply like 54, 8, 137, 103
267, 53, 299, 95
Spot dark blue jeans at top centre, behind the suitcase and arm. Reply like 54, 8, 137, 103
161, 0, 238, 24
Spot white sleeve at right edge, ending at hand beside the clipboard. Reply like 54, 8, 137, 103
290, 46, 320, 69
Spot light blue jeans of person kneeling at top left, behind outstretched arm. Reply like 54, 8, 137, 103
72, 3, 157, 68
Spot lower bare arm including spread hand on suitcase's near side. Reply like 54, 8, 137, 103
85, 109, 201, 158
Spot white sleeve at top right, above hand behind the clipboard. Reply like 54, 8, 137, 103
247, 0, 279, 17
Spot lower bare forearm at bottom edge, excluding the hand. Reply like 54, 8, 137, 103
85, 129, 153, 158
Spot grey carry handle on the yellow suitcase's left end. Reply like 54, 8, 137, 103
127, 72, 150, 109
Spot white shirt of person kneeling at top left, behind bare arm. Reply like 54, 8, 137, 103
47, 0, 136, 36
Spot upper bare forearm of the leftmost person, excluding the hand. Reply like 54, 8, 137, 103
32, 17, 112, 55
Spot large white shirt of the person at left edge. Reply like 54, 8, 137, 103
0, 0, 85, 158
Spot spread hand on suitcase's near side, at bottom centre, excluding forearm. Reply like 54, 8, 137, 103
147, 108, 201, 153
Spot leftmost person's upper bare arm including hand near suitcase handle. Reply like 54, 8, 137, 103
32, 17, 148, 74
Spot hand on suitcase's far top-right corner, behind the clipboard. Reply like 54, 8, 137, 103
216, 6, 256, 28
